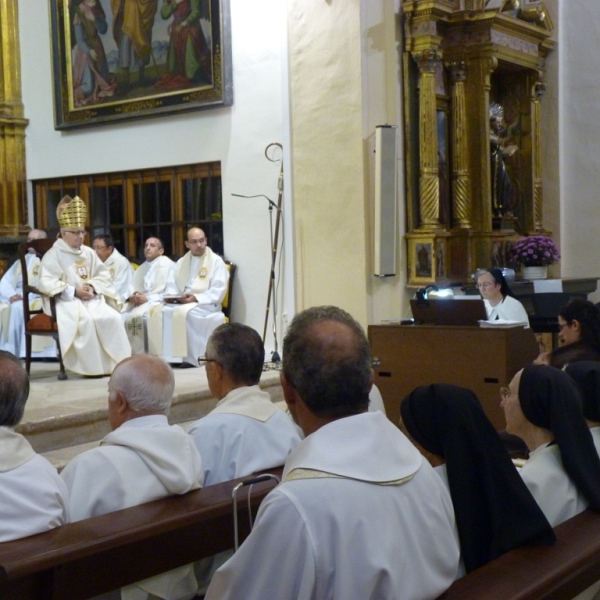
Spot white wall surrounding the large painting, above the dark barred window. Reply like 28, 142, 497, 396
19, 0, 293, 348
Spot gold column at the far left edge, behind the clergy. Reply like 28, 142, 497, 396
0, 0, 29, 236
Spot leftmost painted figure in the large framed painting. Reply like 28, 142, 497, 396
72, 0, 117, 106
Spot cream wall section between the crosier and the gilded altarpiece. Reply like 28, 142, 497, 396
288, 0, 405, 325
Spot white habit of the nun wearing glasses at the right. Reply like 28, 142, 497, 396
519, 444, 588, 527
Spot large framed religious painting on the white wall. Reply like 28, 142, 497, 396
50, 0, 233, 129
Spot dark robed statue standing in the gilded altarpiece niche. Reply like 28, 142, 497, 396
490, 102, 518, 217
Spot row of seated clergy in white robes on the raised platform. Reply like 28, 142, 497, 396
0, 196, 229, 377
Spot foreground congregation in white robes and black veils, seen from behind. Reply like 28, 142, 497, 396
0, 247, 600, 600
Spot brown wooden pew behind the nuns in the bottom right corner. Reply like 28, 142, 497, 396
439, 510, 600, 600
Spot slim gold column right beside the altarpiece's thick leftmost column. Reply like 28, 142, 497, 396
446, 61, 471, 229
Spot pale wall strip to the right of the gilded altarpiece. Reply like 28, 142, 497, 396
553, 0, 600, 301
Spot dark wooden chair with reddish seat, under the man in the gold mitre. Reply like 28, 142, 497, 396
18, 238, 67, 381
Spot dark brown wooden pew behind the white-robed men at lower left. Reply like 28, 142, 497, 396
0, 468, 282, 600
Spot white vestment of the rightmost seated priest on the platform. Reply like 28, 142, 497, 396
156, 247, 229, 367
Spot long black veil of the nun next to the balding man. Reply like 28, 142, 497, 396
401, 384, 555, 573
